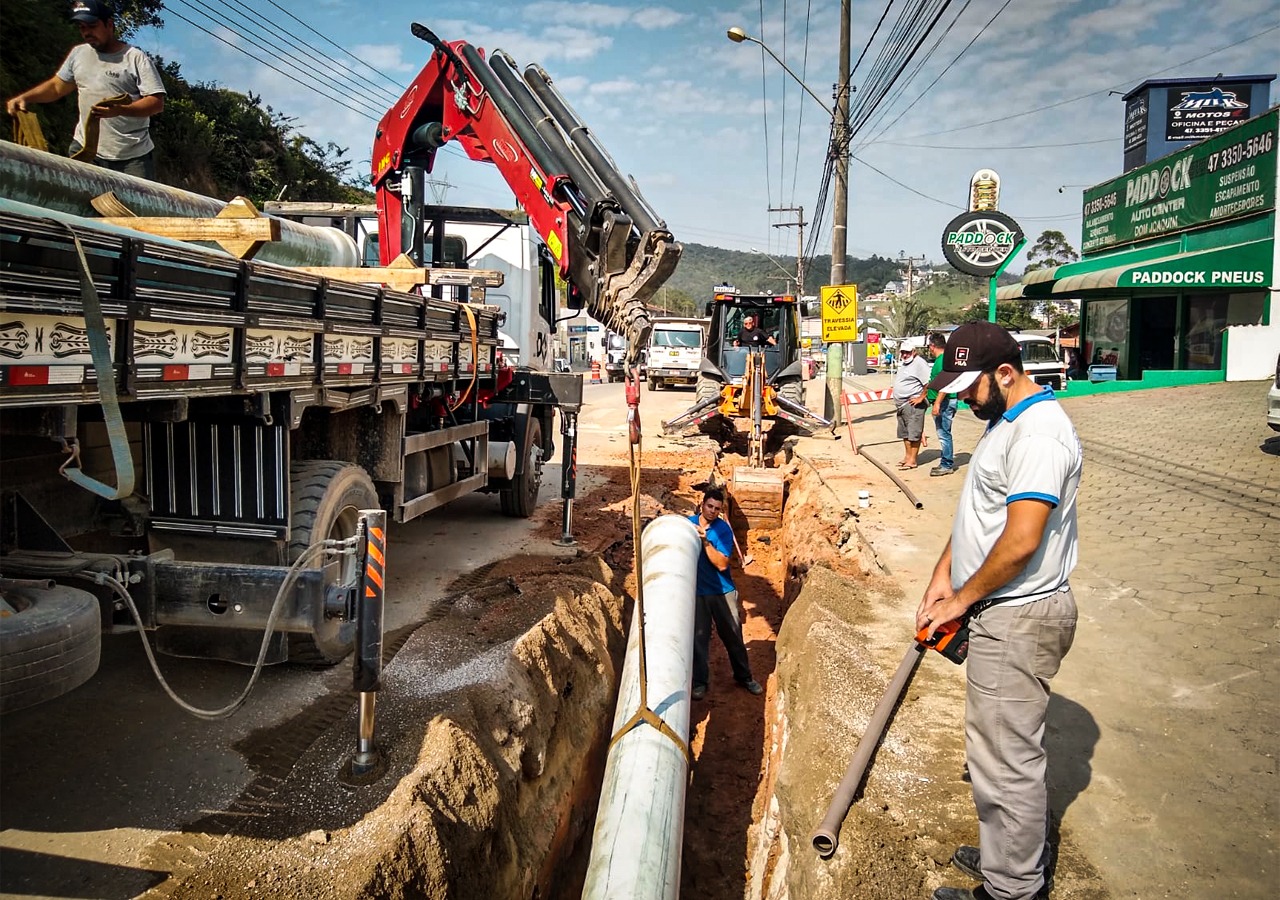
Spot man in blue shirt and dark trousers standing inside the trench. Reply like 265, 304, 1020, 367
689, 488, 764, 700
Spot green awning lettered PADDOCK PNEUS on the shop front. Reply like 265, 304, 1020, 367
1049, 241, 1272, 294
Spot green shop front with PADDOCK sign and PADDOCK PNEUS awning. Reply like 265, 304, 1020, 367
996, 108, 1280, 384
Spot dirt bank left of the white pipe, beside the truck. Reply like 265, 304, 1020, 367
151, 557, 623, 900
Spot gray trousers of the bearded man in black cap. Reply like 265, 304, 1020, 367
965, 589, 1076, 900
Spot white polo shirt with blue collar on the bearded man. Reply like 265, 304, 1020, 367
951, 387, 1084, 606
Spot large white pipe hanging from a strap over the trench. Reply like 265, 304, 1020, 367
582, 516, 703, 900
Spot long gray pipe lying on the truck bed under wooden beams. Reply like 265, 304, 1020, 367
0, 141, 358, 266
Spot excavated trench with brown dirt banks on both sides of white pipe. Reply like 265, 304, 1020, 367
146, 453, 1100, 900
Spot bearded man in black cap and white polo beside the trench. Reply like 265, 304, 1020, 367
915, 323, 1083, 900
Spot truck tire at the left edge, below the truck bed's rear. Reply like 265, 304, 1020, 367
0, 585, 102, 713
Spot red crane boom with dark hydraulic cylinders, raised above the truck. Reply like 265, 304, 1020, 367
372, 23, 681, 364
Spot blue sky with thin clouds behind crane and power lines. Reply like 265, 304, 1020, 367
134, 0, 1280, 270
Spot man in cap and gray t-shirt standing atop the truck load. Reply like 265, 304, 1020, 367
6, 0, 165, 179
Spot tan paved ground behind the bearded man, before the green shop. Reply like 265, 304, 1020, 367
849, 375, 1280, 900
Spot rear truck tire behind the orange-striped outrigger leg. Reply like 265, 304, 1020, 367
289, 460, 380, 666
